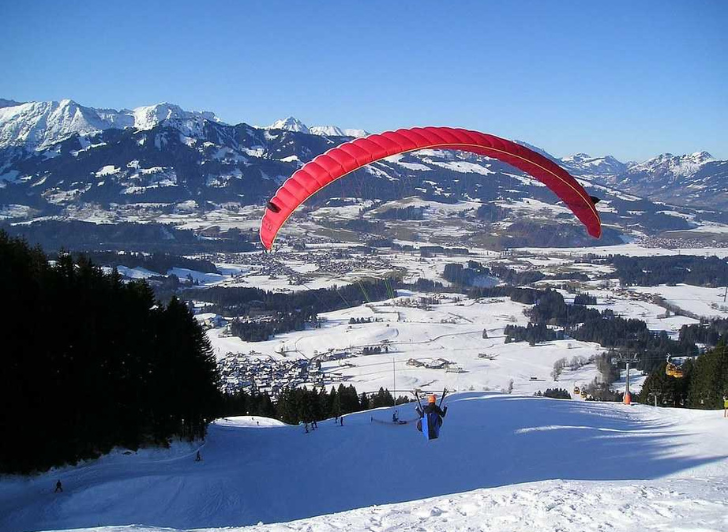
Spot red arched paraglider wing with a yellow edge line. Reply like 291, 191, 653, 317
260, 127, 602, 249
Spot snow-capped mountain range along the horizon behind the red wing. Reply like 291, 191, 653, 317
0, 100, 728, 243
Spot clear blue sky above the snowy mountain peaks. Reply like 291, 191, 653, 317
0, 0, 728, 160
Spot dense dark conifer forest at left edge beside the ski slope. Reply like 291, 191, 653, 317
0, 231, 219, 472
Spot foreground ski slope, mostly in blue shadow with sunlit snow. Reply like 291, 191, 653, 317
0, 392, 728, 532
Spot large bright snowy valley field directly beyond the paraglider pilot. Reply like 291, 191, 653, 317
208, 294, 604, 395
